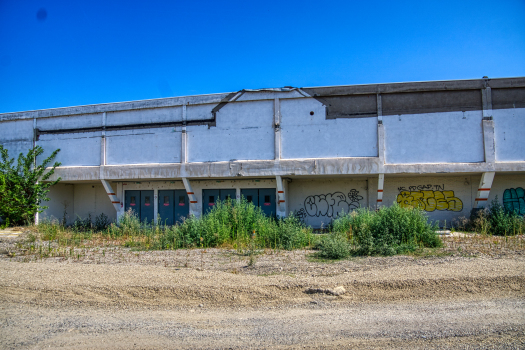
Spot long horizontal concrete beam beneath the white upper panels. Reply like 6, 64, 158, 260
44, 157, 525, 182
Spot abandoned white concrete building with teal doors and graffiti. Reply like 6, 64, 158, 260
0, 78, 525, 227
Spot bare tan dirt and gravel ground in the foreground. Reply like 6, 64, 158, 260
0, 231, 525, 349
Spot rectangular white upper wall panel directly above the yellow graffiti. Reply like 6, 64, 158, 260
383, 111, 485, 164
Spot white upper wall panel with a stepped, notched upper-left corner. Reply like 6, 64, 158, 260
187, 101, 274, 162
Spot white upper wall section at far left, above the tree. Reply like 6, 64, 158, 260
0, 120, 33, 161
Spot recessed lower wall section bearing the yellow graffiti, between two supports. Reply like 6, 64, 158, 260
383, 176, 472, 227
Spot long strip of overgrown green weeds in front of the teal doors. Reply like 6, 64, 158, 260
38, 200, 312, 251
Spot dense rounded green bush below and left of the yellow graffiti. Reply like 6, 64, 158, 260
333, 204, 442, 256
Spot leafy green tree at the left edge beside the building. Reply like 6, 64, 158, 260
0, 145, 61, 226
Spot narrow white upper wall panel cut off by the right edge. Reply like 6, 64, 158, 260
492, 108, 525, 162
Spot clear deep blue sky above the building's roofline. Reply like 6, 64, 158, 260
0, 0, 525, 113
